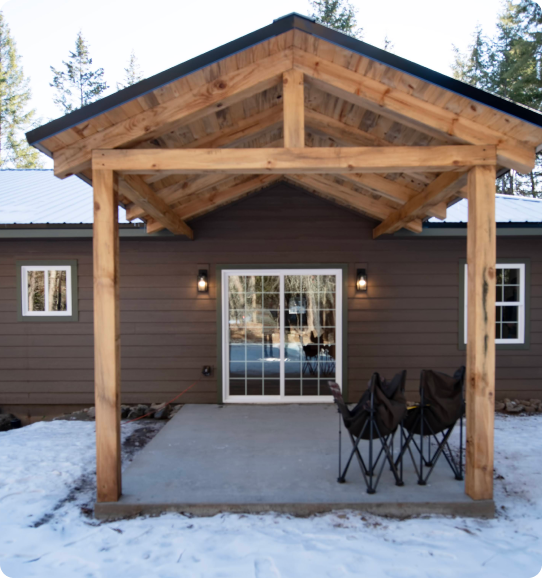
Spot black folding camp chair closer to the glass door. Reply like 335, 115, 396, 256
329, 371, 406, 494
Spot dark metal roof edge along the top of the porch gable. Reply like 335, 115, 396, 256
26, 13, 542, 156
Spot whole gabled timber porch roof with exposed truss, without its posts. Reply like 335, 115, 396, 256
28, 14, 542, 238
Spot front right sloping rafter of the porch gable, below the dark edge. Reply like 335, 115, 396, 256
294, 48, 535, 172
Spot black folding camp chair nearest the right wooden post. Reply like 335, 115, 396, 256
395, 367, 465, 486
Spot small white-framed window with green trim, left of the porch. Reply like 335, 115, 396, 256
17, 261, 77, 321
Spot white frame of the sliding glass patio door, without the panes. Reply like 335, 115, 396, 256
221, 268, 343, 404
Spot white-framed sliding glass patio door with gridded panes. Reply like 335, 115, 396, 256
222, 269, 342, 403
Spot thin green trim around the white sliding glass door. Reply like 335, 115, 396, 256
218, 263, 349, 404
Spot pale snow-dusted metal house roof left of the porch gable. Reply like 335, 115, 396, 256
0, 170, 136, 225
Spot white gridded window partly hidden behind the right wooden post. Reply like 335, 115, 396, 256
464, 263, 526, 345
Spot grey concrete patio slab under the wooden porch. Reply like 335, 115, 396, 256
95, 405, 495, 519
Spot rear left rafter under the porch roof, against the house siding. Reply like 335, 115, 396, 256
147, 175, 280, 233
